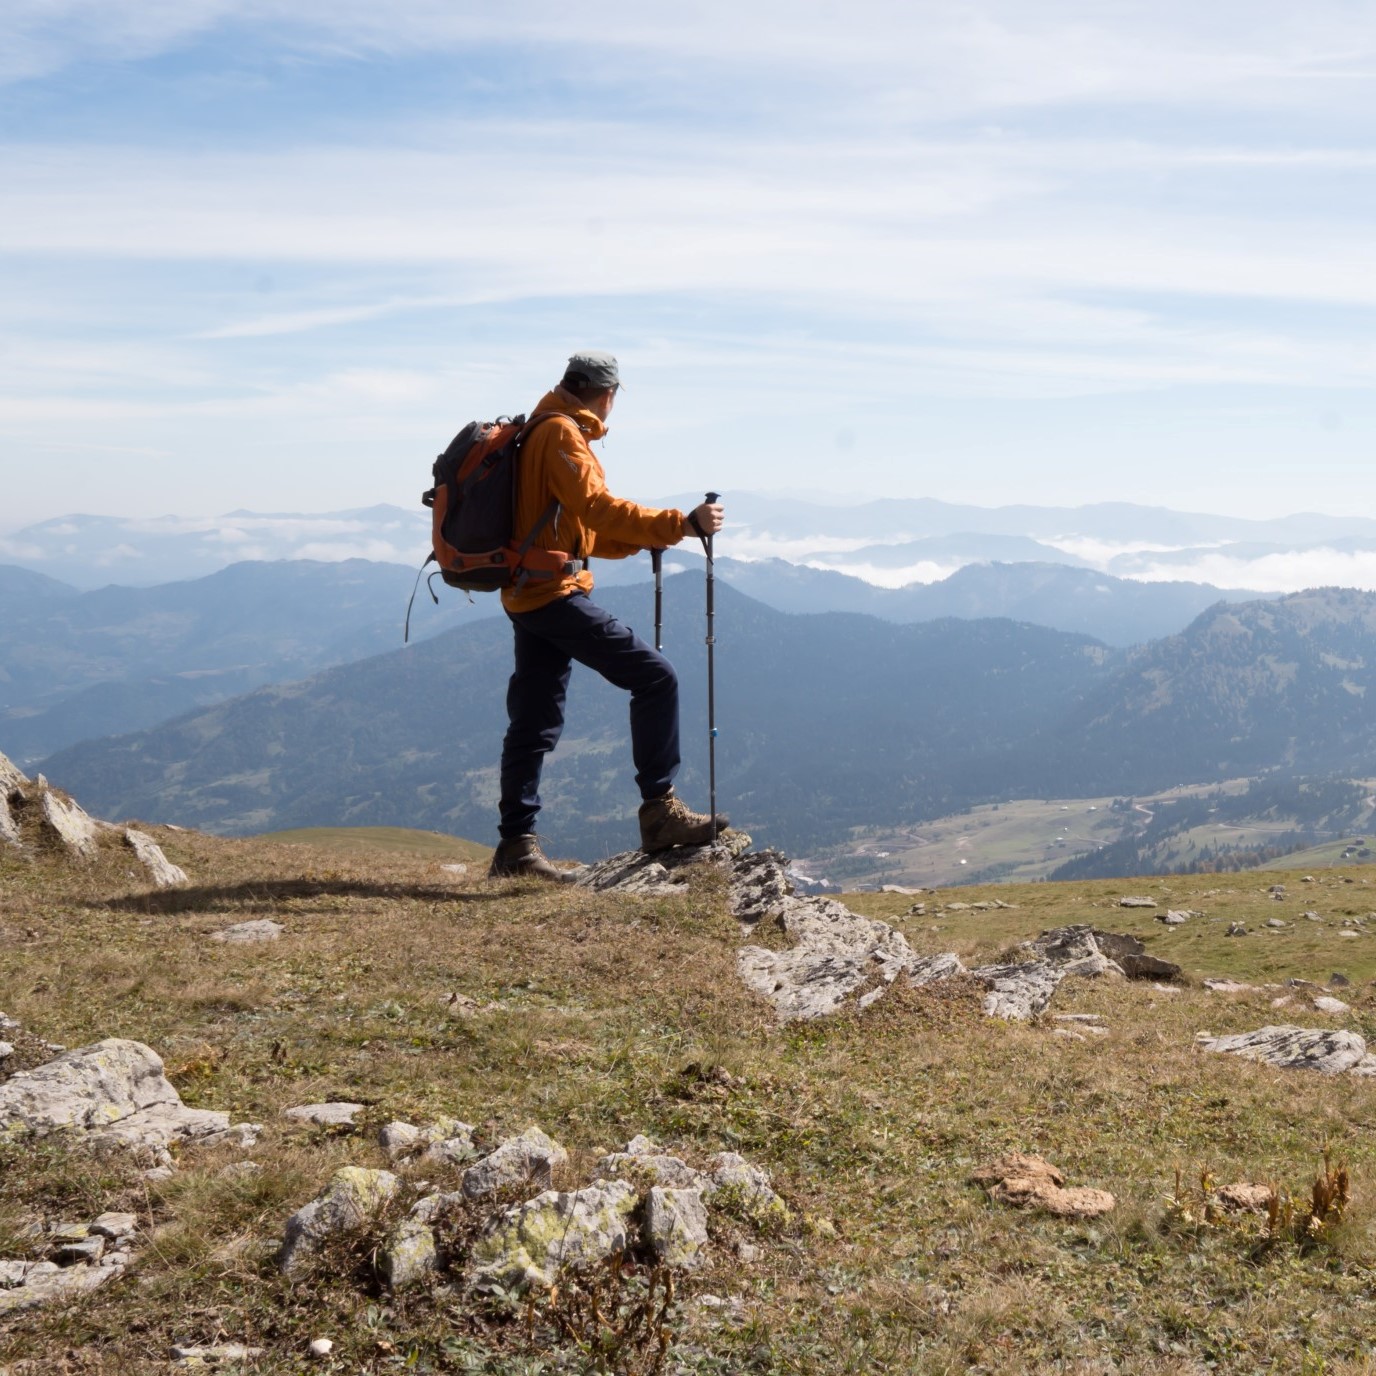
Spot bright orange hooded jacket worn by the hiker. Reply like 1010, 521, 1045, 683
502, 387, 684, 611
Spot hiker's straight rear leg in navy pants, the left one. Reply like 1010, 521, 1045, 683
498, 612, 572, 839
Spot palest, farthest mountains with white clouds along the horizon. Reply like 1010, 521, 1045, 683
0, 493, 1376, 590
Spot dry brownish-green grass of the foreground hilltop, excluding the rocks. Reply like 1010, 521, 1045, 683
0, 831, 1376, 1376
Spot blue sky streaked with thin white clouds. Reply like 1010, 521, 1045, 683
0, 0, 1376, 531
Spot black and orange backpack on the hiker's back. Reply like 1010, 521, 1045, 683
406, 411, 577, 638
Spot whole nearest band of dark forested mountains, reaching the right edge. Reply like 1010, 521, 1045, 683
34, 575, 1376, 856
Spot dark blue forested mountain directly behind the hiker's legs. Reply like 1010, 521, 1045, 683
43, 575, 1115, 856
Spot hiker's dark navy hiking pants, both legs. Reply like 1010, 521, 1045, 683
498, 593, 678, 838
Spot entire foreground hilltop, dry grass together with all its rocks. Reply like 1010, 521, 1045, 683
0, 766, 1376, 1376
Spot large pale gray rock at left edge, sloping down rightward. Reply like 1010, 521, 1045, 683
0, 1038, 255, 1150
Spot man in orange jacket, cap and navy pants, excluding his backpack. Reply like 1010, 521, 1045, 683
488, 350, 728, 881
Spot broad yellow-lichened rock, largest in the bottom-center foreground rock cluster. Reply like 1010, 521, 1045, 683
471, 1181, 637, 1291
